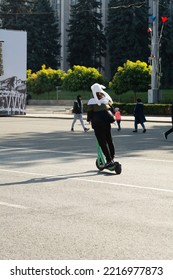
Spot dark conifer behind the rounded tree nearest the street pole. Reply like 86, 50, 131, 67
107, 0, 149, 75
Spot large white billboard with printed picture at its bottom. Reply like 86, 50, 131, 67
0, 29, 27, 115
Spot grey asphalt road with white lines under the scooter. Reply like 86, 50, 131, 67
0, 117, 173, 260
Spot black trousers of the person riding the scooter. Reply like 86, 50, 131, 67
93, 123, 115, 162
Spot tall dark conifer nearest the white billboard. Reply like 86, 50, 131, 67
28, 0, 60, 72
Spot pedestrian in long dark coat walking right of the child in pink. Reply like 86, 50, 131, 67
133, 98, 146, 133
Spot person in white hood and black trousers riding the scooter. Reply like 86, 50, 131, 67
87, 83, 115, 167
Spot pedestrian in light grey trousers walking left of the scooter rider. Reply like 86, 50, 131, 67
71, 95, 89, 132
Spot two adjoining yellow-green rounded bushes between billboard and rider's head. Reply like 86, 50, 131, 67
27, 65, 108, 95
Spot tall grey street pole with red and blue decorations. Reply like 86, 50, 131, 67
148, 0, 160, 103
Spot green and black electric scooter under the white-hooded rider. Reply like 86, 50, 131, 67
96, 142, 122, 174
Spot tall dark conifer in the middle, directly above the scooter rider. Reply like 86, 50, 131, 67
68, 0, 106, 70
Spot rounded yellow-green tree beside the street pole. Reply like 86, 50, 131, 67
110, 60, 151, 99
